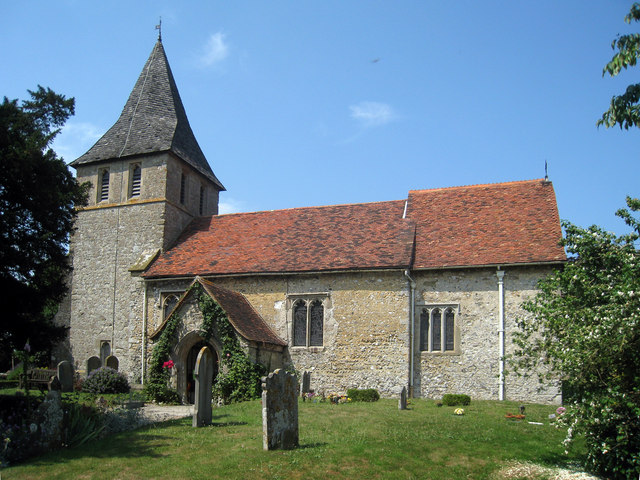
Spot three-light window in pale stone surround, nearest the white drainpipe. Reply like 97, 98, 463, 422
419, 305, 459, 352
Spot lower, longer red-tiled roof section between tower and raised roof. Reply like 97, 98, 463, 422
144, 201, 415, 278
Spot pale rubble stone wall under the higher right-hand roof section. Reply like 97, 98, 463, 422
414, 267, 560, 403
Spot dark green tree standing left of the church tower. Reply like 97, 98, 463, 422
0, 86, 87, 369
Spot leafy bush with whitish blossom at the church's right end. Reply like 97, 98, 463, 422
512, 198, 640, 479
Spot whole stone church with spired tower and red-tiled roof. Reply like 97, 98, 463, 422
56, 40, 566, 403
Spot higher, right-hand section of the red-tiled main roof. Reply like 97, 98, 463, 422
407, 180, 566, 269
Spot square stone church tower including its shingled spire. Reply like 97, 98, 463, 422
59, 39, 224, 382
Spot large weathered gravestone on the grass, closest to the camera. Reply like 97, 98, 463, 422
262, 369, 299, 450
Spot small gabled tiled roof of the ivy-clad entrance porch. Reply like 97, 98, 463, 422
149, 277, 287, 346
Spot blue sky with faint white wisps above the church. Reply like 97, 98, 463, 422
0, 0, 640, 233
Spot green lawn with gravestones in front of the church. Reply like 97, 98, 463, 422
1, 400, 582, 480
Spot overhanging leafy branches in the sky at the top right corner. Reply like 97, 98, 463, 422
597, 3, 640, 129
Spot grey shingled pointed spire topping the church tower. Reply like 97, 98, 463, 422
71, 39, 225, 190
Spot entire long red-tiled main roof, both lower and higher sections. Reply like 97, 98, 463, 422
143, 180, 566, 278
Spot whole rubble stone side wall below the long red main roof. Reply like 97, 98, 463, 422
148, 267, 559, 403
